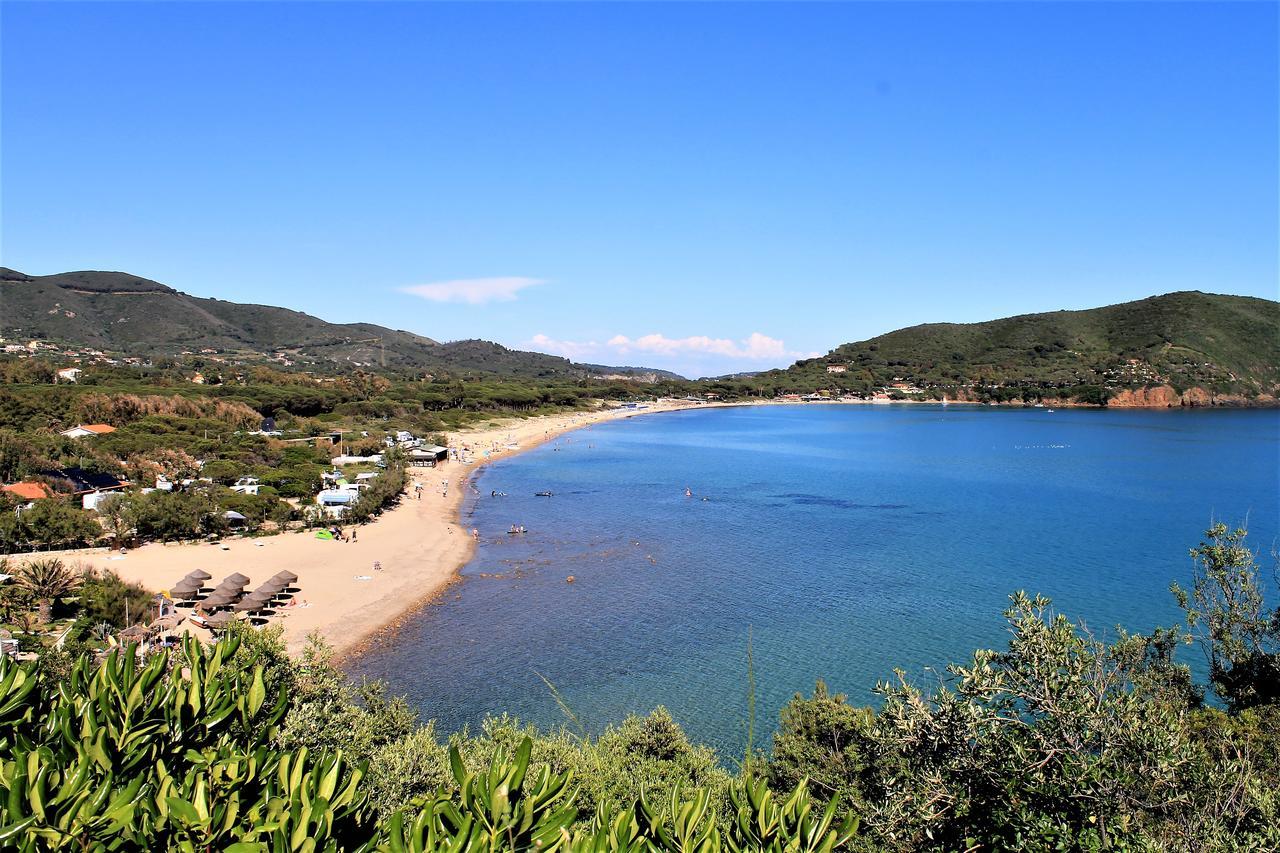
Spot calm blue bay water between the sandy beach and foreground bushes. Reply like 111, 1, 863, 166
351, 405, 1280, 756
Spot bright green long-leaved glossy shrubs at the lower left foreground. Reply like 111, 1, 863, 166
0, 638, 856, 852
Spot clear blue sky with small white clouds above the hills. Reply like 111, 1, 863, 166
0, 3, 1280, 375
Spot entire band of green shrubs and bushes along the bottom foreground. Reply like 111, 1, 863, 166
0, 525, 1280, 853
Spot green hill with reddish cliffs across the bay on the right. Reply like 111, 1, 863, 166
762, 291, 1280, 405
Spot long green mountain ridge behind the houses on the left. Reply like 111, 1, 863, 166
0, 262, 589, 377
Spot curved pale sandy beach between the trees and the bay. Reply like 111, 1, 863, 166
49, 401, 706, 656
